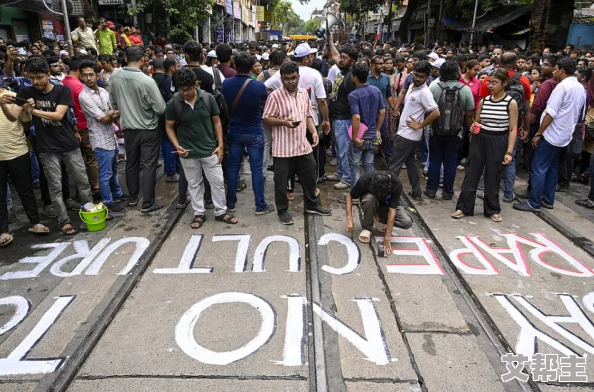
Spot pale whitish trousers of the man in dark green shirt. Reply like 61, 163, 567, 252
181, 155, 227, 216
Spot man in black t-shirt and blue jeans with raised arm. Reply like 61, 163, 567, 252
326, 35, 359, 189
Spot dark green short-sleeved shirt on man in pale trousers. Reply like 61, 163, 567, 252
165, 90, 220, 159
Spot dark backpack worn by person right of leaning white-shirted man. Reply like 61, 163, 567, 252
432, 82, 464, 136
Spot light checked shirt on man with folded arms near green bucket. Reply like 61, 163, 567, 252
78, 86, 117, 150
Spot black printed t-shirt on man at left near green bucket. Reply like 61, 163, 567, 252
17, 85, 79, 153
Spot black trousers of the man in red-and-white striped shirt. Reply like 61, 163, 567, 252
274, 153, 320, 213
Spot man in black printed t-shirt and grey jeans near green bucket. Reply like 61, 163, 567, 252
5, 57, 93, 235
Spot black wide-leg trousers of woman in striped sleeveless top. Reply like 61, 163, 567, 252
456, 132, 509, 216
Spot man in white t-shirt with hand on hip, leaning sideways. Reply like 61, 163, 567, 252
390, 60, 439, 200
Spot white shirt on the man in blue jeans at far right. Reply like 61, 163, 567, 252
540, 76, 586, 147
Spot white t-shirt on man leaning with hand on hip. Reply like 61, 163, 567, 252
398, 83, 437, 141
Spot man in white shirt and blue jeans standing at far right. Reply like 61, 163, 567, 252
514, 58, 586, 212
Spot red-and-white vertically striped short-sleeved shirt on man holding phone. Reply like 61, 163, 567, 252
262, 87, 313, 158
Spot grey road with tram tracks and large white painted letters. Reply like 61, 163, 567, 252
0, 158, 594, 392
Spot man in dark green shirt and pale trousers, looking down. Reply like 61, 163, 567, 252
165, 68, 238, 229
